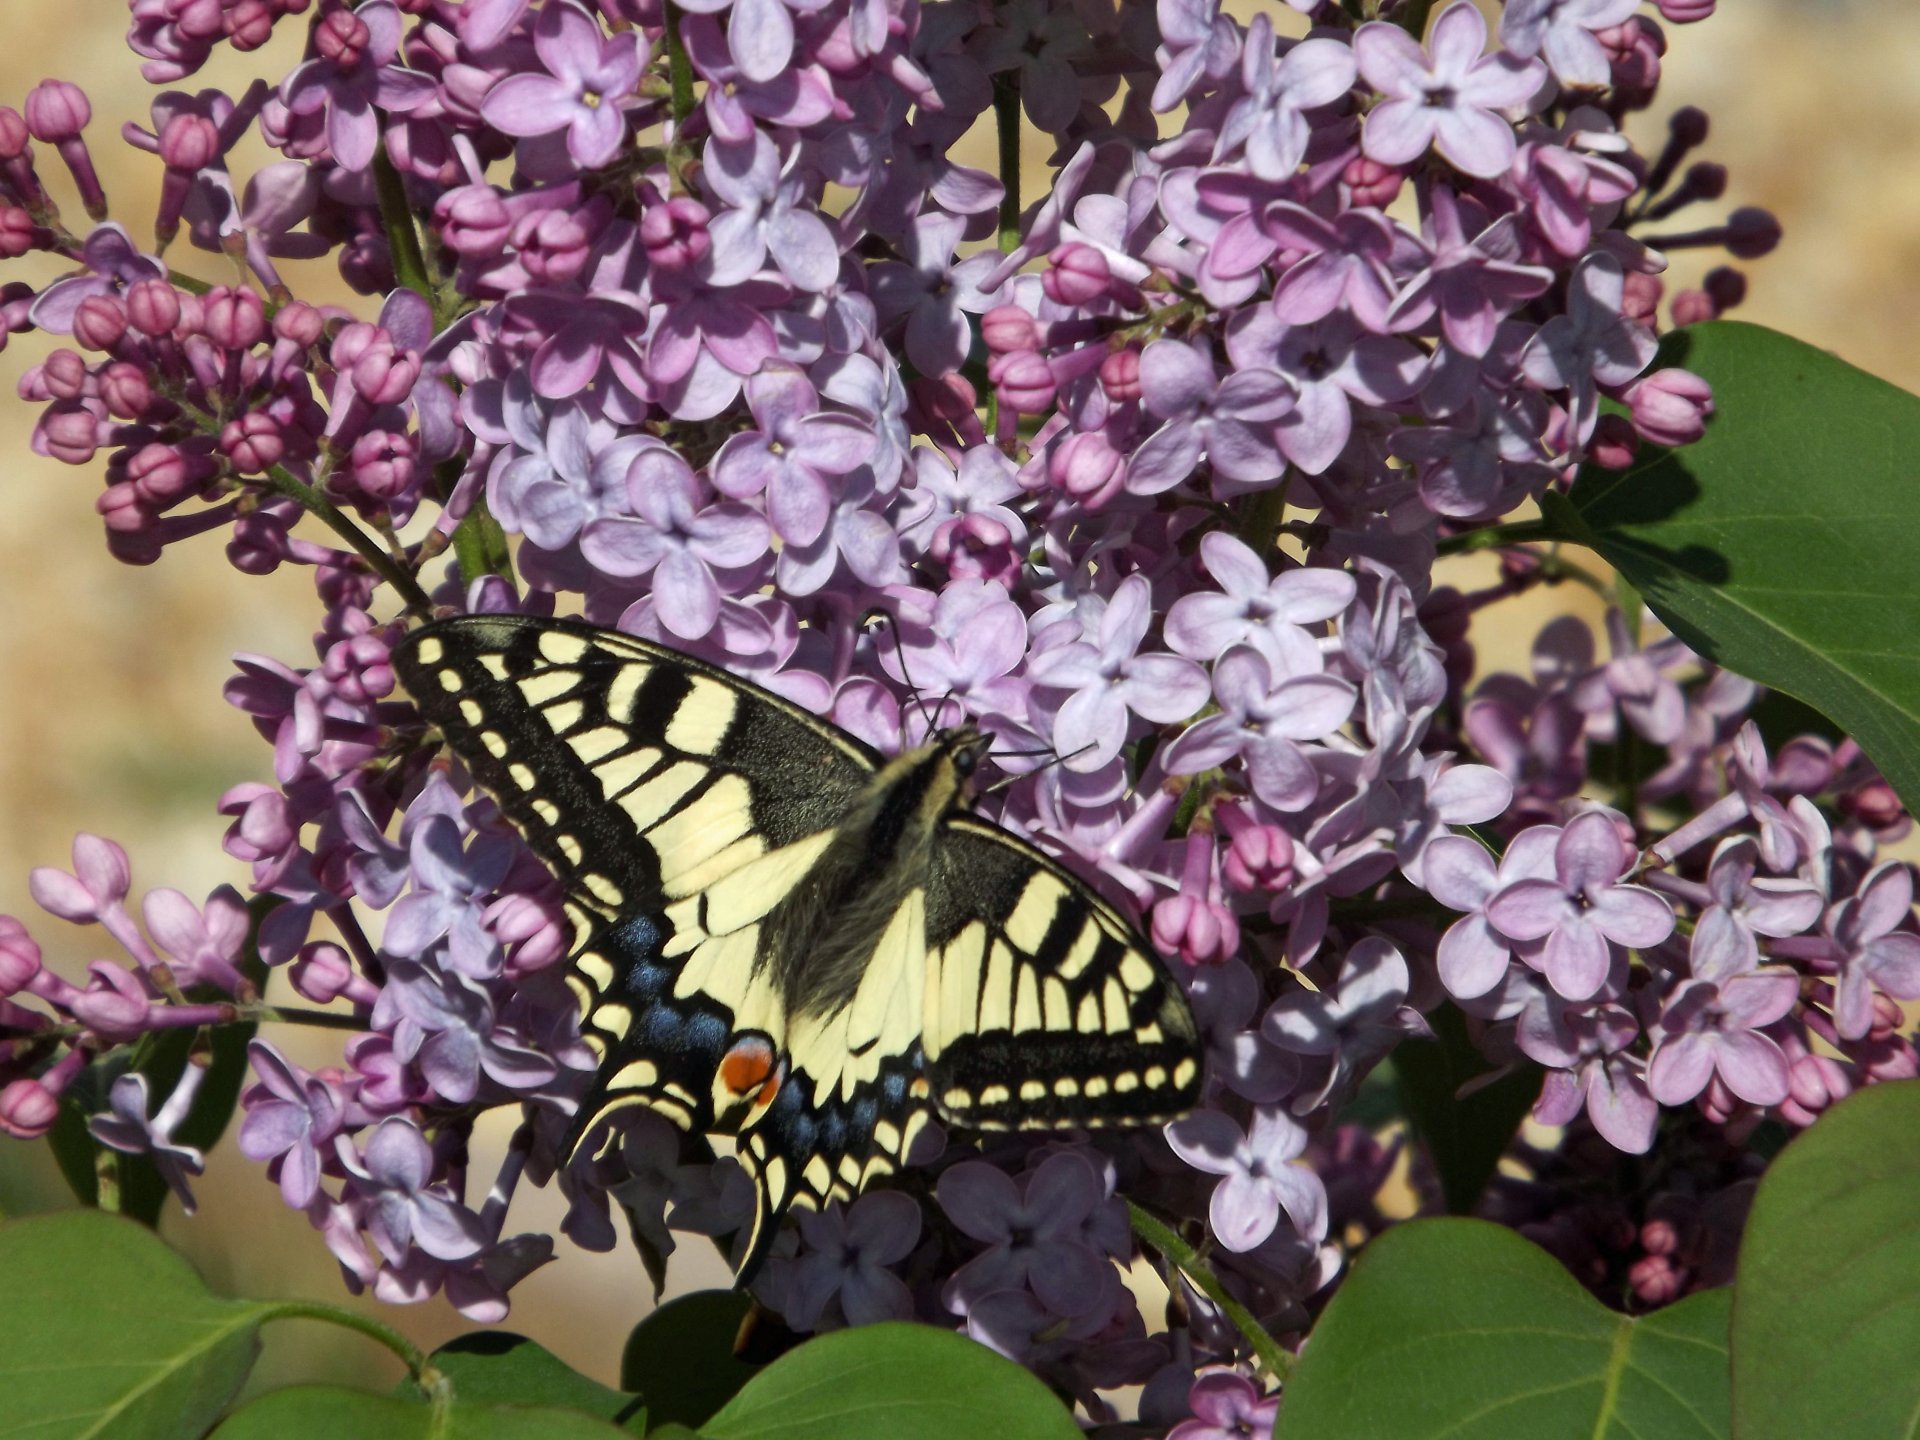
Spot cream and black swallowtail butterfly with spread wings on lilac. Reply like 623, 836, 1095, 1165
394, 614, 1200, 1279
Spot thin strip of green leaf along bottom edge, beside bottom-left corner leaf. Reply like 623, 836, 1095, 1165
213, 1384, 628, 1440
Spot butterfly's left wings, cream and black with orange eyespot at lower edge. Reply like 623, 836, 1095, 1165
394, 616, 879, 1140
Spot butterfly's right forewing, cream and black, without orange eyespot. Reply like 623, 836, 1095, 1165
924, 816, 1200, 1129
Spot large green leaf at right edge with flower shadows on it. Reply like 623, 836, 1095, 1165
1544, 321, 1920, 808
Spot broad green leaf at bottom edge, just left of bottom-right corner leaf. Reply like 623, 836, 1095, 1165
1273, 1219, 1730, 1440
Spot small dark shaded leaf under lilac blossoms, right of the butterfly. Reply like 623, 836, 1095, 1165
1394, 1004, 1540, 1215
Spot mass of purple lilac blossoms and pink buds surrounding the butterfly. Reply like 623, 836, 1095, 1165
0, 0, 1920, 1440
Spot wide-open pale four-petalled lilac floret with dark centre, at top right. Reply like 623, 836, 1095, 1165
1354, 4, 1546, 177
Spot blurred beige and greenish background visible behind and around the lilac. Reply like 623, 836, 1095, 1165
0, 0, 1920, 1384
